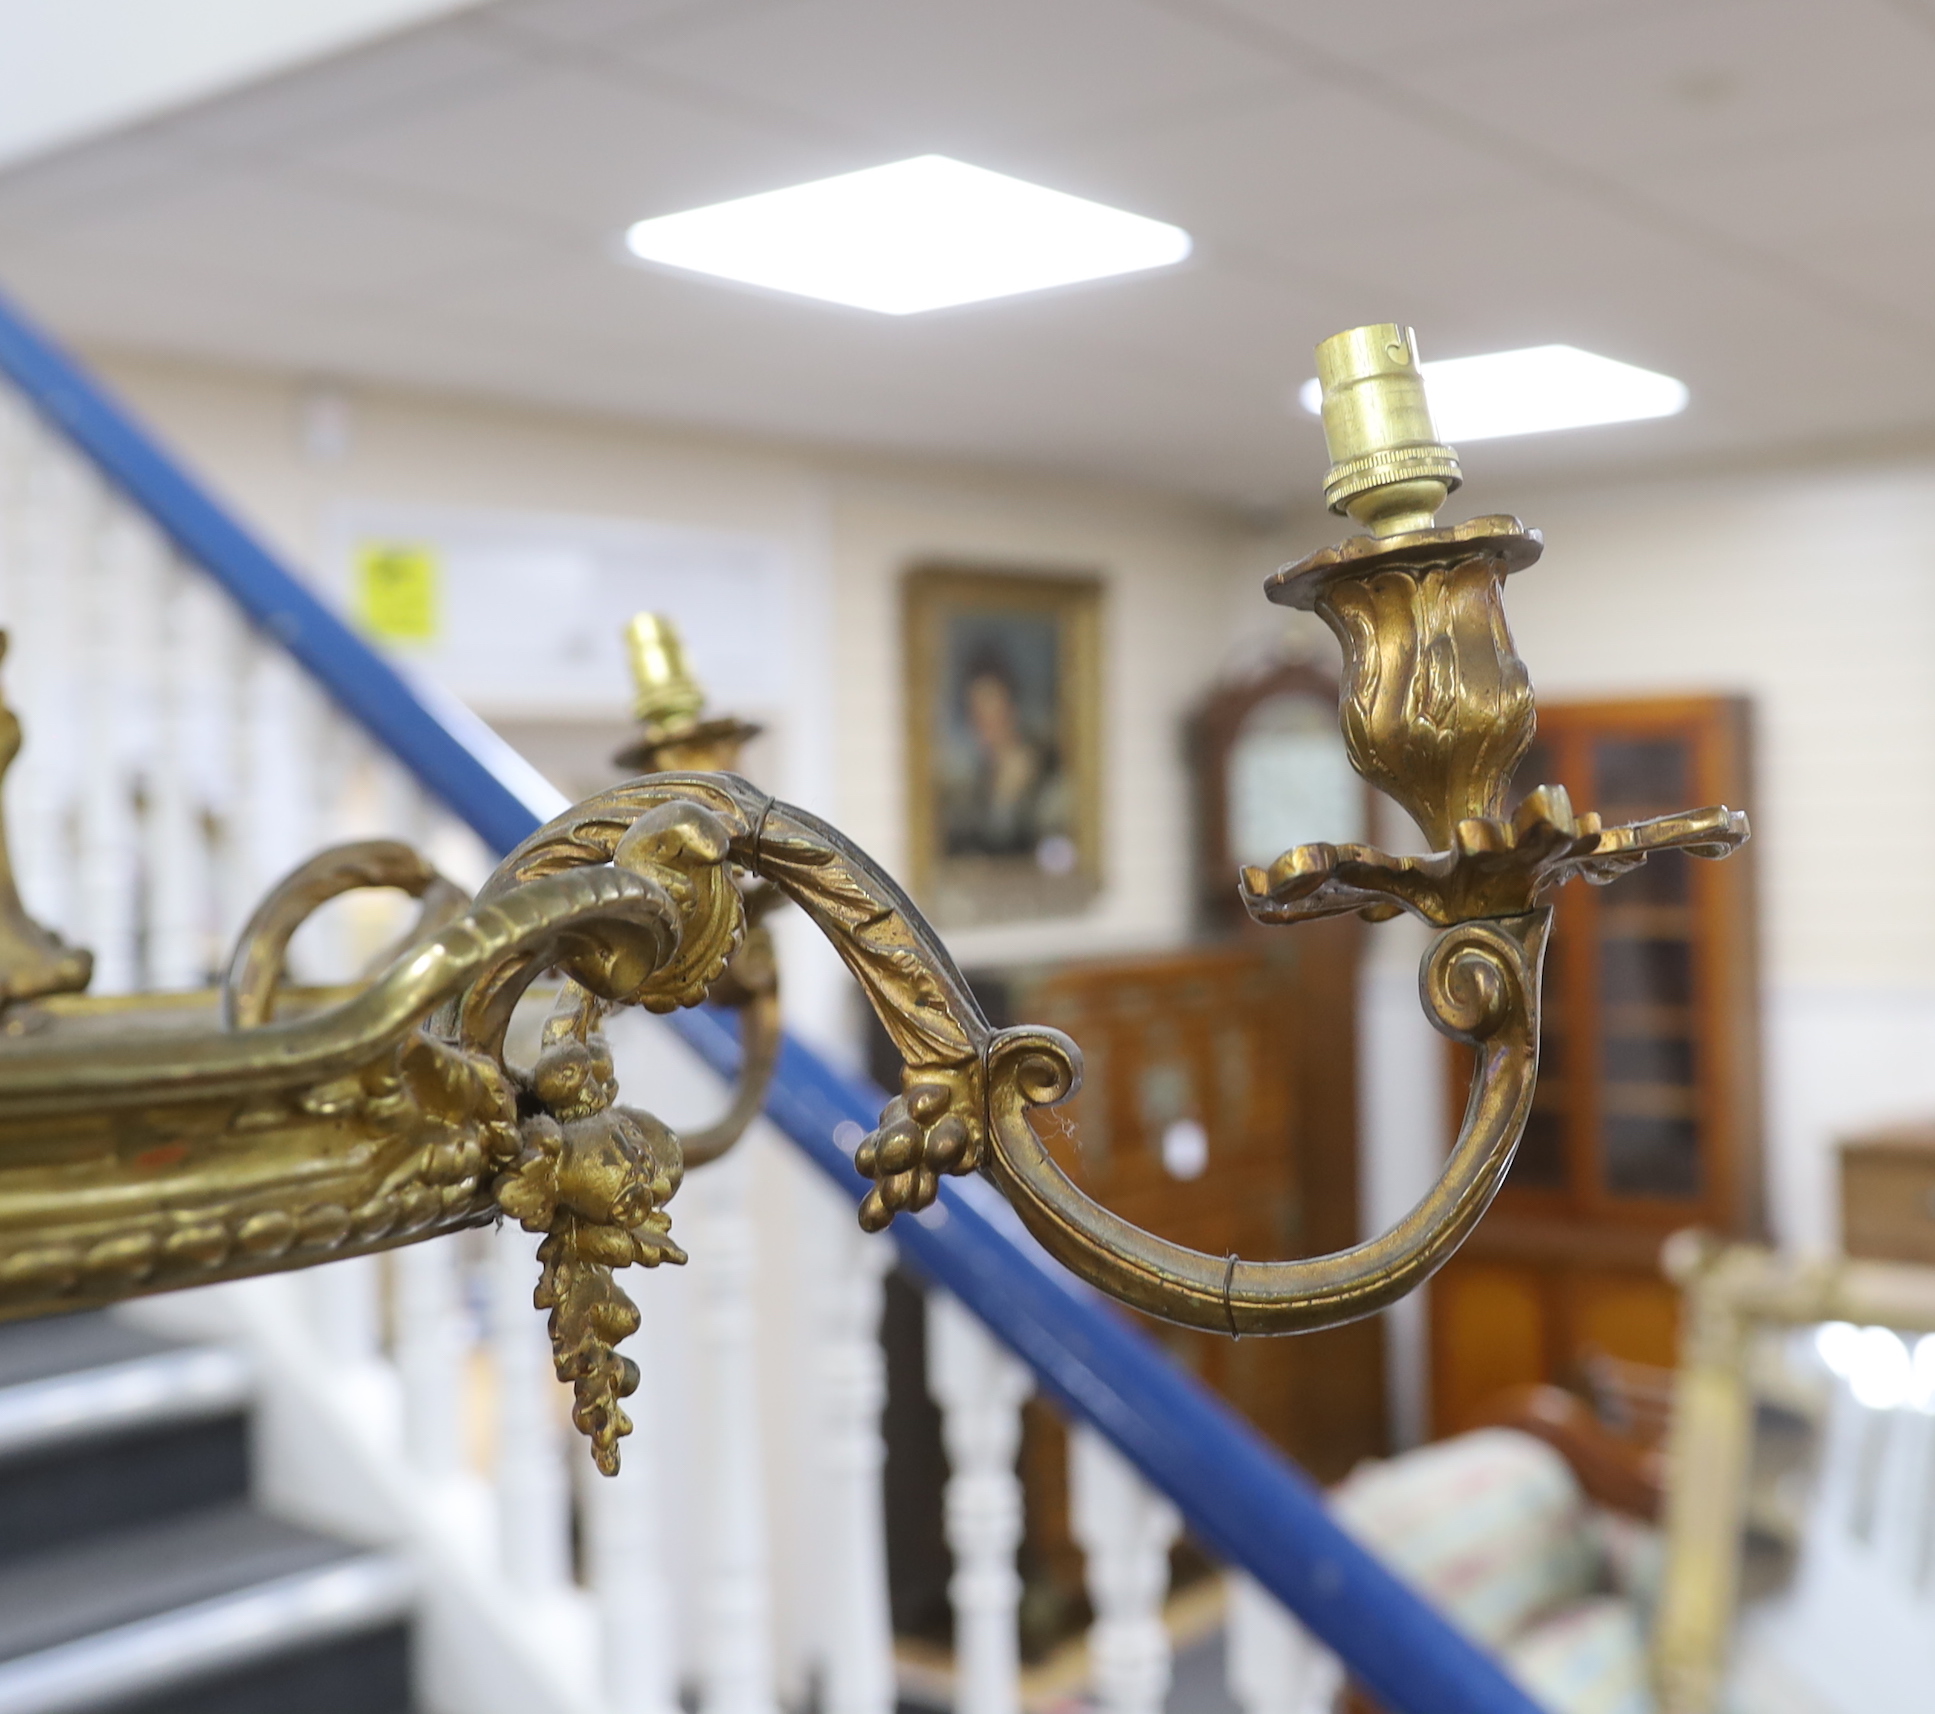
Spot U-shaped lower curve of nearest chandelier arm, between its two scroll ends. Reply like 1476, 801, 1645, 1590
983, 909, 1552, 1335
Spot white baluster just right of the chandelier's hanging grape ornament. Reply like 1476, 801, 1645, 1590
683, 1149, 778, 1714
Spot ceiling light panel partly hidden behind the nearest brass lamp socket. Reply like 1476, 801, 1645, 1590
1296, 344, 1687, 445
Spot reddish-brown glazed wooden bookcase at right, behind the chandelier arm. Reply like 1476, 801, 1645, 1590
1430, 696, 1763, 1435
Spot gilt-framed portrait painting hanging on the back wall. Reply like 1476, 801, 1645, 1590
906, 565, 1101, 927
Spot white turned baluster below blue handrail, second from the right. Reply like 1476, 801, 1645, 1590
1068, 1426, 1182, 1714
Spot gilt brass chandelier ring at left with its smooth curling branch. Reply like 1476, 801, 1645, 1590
0, 865, 737, 1338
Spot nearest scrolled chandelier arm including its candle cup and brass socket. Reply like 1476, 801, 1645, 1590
642, 325, 1747, 1333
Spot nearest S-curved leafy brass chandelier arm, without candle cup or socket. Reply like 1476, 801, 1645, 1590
486, 774, 1550, 1333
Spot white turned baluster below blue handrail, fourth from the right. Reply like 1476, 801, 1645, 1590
799, 1184, 894, 1714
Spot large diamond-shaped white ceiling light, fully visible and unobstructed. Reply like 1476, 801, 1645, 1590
625, 155, 1190, 315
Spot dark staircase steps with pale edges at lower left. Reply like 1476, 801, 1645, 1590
0, 1314, 412, 1714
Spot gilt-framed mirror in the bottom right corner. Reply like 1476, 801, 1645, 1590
1652, 1232, 1935, 1714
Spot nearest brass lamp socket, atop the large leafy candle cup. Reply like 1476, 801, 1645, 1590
1318, 321, 1465, 536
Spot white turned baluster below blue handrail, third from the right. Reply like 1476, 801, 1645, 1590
927, 1290, 1035, 1714
